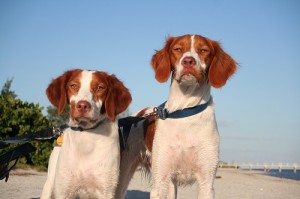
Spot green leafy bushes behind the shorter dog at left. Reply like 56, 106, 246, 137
0, 79, 67, 167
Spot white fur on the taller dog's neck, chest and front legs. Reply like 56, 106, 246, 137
151, 81, 219, 199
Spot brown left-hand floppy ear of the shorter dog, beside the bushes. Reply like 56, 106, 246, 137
46, 70, 74, 115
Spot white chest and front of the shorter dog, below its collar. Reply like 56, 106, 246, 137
50, 120, 120, 199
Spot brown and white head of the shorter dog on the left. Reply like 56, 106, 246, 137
46, 69, 131, 128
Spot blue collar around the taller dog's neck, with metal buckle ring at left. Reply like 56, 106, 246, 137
156, 99, 211, 120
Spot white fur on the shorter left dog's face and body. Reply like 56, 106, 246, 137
41, 71, 120, 199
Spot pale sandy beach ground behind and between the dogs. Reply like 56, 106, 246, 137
0, 169, 300, 199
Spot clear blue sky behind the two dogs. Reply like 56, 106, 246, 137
0, 0, 300, 163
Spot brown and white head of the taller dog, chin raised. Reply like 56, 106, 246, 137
151, 35, 237, 88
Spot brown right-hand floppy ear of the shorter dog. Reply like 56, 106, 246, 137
105, 75, 131, 121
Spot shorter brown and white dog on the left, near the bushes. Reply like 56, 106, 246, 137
41, 69, 131, 199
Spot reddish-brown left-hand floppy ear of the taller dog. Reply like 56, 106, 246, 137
151, 37, 174, 83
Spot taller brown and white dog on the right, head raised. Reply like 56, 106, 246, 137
117, 35, 237, 199
